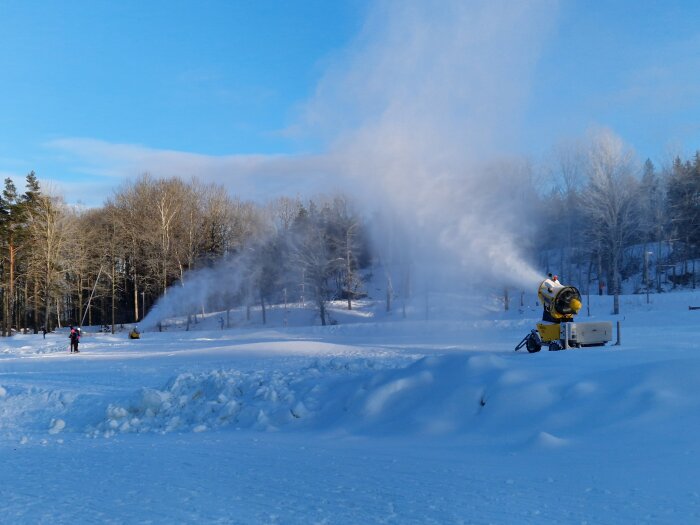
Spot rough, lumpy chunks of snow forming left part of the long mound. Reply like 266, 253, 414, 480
91, 359, 386, 437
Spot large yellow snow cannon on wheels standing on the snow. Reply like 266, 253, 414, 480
515, 276, 612, 353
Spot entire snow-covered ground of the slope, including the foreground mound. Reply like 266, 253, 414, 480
0, 293, 700, 524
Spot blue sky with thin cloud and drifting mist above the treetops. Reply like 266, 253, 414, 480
0, 0, 700, 205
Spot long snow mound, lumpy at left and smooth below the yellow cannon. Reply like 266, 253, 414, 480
89, 348, 700, 447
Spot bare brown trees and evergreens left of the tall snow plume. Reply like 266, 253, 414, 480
0, 172, 370, 335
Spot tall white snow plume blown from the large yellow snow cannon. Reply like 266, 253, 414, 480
307, 0, 554, 286
